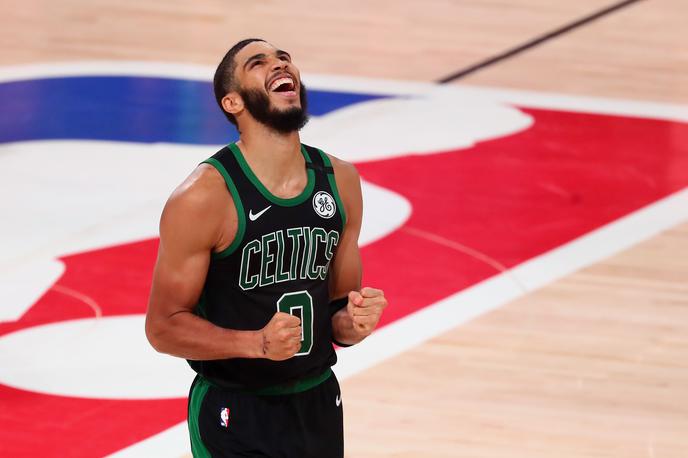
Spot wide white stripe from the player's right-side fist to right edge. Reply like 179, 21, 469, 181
334, 188, 688, 379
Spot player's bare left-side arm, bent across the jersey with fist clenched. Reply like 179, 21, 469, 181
146, 166, 301, 360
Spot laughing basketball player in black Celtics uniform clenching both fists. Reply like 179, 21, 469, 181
146, 39, 387, 458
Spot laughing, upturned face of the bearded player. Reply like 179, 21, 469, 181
235, 41, 308, 133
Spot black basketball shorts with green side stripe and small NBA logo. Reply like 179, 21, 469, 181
188, 371, 344, 458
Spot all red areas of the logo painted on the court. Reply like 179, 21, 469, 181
0, 109, 688, 457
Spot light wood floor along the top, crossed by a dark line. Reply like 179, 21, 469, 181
0, 0, 688, 102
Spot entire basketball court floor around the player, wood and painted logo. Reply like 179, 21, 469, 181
0, 0, 688, 458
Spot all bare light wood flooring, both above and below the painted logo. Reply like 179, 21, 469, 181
0, 0, 688, 458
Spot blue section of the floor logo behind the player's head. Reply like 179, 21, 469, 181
0, 76, 385, 145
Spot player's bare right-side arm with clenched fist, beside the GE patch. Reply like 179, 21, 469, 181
330, 158, 387, 345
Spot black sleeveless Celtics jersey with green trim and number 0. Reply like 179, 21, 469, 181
189, 144, 346, 389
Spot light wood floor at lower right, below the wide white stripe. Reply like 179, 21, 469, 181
343, 225, 688, 458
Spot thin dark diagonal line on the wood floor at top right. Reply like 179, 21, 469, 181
436, 0, 641, 84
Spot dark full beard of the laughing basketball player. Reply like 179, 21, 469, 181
238, 84, 308, 134
